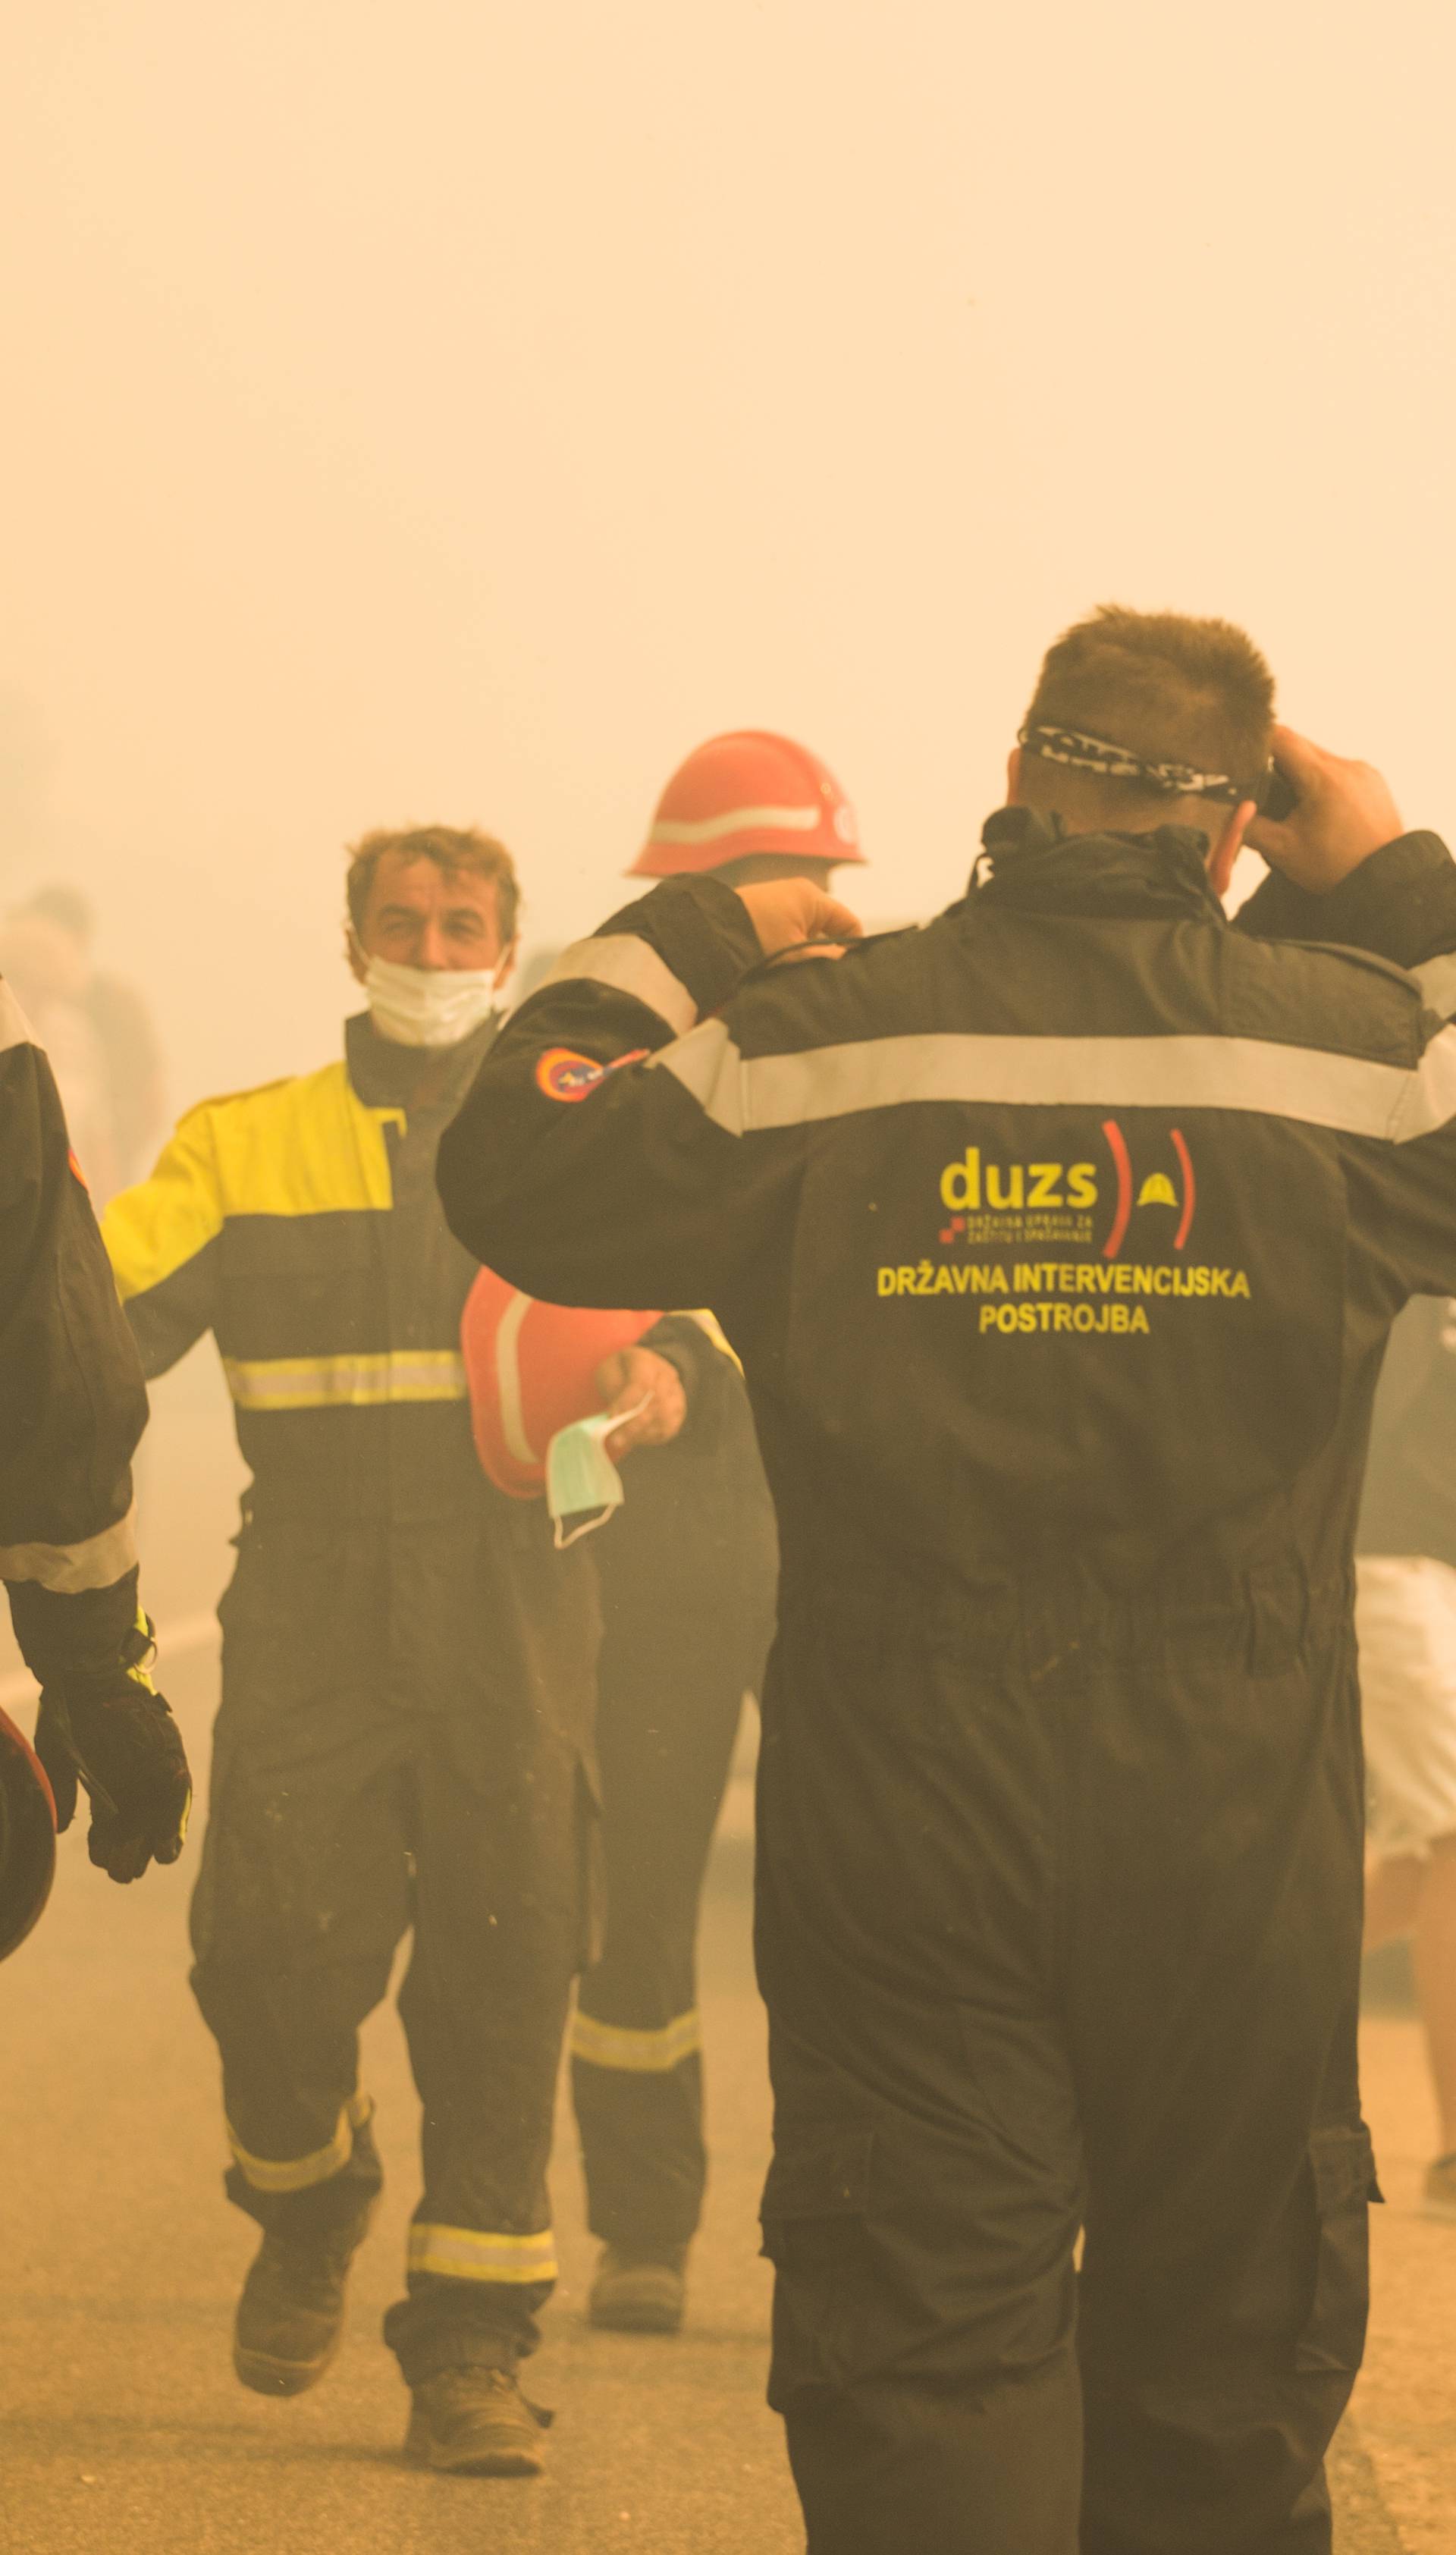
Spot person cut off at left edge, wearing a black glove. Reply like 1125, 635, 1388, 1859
0, 984, 192, 1954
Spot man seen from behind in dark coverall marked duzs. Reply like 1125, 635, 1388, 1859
439, 611, 1456, 2555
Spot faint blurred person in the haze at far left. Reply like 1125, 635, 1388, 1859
0, 884, 164, 1206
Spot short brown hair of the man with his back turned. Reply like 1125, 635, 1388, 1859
1025, 603, 1275, 815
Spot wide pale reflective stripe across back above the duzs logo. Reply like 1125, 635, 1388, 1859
644, 1019, 1456, 1144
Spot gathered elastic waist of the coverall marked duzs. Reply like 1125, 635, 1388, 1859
779, 1551, 1354, 1678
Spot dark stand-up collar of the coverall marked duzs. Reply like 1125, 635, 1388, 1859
971, 808, 1223, 920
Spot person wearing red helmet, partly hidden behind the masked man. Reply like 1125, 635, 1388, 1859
562, 728, 848, 2333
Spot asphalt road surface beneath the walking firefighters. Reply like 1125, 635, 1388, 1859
0, 1362, 1456, 2555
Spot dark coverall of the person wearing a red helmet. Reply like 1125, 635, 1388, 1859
573, 1316, 779, 2262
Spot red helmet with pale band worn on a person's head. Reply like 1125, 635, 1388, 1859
629, 728, 864, 879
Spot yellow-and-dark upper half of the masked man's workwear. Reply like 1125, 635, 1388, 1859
105, 1019, 491, 1518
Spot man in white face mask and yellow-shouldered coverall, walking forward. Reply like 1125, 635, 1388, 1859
105, 828, 598, 2473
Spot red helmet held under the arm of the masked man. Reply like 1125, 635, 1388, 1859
460, 1270, 661, 1500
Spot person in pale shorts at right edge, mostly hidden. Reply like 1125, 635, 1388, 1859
1357, 1277, 1456, 2223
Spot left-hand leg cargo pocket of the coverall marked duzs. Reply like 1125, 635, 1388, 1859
758, 2128, 874, 2412
